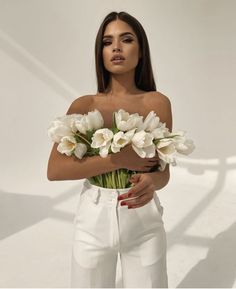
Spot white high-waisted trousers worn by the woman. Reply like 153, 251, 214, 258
71, 179, 168, 288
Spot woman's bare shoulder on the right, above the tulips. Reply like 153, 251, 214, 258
145, 91, 172, 130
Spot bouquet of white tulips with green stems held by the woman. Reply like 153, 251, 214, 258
48, 109, 195, 189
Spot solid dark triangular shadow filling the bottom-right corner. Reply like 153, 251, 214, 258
177, 223, 236, 288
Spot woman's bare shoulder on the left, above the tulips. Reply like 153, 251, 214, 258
67, 94, 93, 114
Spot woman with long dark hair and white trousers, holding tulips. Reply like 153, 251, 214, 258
48, 12, 172, 288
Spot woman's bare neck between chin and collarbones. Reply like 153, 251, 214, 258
106, 71, 139, 97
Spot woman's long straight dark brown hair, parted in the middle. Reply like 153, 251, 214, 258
95, 11, 156, 92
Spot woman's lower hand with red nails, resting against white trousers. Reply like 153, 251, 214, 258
118, 173, 155, 209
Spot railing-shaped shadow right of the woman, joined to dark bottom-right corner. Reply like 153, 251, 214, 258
167, 158, 236, 288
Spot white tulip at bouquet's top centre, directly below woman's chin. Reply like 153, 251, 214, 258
115, 109, 143, 131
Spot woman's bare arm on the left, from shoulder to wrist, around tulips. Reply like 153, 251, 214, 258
47, 96, 118, 181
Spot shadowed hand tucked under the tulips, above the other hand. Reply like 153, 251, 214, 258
113, 144, 159, 172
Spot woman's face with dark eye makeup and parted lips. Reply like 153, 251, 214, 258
103, 19, 141, 74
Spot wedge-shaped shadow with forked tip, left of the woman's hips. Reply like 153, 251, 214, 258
0, 187, 78, 240
